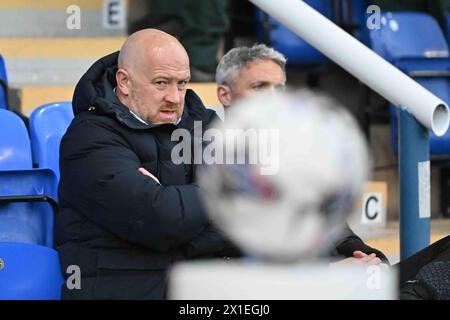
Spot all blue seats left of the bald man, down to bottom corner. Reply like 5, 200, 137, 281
0, 102, 73, 300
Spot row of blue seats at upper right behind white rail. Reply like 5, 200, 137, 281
257, 5, 450, 156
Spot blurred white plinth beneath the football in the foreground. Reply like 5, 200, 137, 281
169, 262, 397, 300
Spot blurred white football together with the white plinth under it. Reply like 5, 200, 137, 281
169, 91, 397, 299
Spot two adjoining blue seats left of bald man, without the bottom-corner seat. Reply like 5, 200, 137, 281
0, 102, 73, 247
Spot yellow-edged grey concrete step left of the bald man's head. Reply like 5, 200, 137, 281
0, 37, 125, 88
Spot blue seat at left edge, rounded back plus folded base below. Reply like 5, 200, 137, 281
0, 109, 57, 247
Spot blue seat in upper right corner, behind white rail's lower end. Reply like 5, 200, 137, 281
370, 12, 450, 155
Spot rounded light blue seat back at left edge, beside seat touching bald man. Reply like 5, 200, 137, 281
0, 109, 33, 170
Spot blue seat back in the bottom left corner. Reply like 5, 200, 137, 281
0, 243, 64, 300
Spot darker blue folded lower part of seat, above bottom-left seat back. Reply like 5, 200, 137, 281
0, 169, 57, 247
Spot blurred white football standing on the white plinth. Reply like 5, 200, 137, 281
198, 90, 370, 261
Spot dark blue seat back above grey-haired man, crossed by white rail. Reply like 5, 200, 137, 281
256, 0, 334, 68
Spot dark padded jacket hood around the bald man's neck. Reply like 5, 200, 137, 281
72, 51, 215, 129
